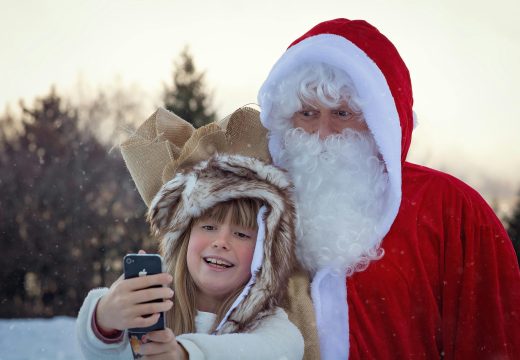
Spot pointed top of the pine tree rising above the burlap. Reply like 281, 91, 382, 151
163, 47, 216, 128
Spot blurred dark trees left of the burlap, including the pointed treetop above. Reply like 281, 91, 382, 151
0, 48, 215, 318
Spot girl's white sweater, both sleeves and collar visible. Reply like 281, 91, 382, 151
76, 288, 303, 360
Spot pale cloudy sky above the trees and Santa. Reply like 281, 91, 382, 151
0, 0, 520, 214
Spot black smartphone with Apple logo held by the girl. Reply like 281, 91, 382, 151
123, 254, 166, 359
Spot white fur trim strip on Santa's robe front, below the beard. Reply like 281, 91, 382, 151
311, 269, 350, 360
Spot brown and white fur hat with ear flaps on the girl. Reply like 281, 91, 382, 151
149, 155, 295, 333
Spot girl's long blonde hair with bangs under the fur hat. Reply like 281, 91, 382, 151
166, 198, 262, 335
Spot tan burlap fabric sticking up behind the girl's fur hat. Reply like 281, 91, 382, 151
121, 107, 271, 206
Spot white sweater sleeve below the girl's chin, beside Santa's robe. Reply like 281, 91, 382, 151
177, 308, 303, 360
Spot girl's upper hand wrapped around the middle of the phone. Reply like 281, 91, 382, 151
95, 260, 173, 333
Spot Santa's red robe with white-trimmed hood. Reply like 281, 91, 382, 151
259, 19, 520, 359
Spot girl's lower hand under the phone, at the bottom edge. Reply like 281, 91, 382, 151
139, 328, 189, 360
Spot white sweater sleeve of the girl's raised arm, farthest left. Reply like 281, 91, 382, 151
76, 288, 133, 360
